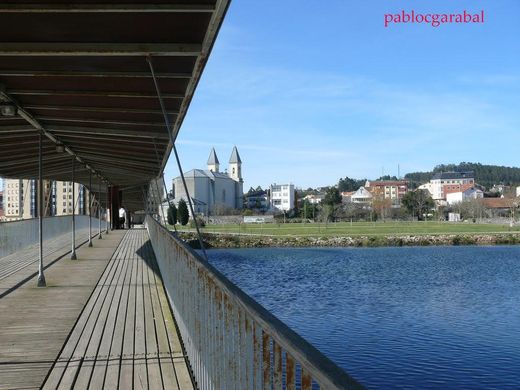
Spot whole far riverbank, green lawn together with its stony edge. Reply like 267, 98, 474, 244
170, 222, 520, 248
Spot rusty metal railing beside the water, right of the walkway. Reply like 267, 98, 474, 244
146, 216, 363, 390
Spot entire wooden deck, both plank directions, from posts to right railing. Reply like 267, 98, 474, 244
0, 229, 193, 389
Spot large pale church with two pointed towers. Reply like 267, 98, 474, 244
173, 146, 244, 216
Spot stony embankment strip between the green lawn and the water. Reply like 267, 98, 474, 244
179, 232, 520, 248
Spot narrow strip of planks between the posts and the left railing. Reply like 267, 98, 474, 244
0, 229, 97, 296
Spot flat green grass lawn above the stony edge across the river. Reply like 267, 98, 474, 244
172, 222, 520, 236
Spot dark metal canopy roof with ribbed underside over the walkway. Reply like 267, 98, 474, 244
0, 0, 229, 209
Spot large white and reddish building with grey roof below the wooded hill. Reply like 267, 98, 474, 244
419, 172, 475, 201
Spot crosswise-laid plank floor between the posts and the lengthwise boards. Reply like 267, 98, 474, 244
0, 231, 125, 389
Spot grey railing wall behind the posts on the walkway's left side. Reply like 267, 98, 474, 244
0, 215, 99, 257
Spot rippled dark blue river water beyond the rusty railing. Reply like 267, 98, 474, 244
208, 246, 520, 389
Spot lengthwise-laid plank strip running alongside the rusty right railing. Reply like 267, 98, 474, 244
43, 229, 193, 389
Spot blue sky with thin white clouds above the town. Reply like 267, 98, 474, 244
166, 0, 520, 190
